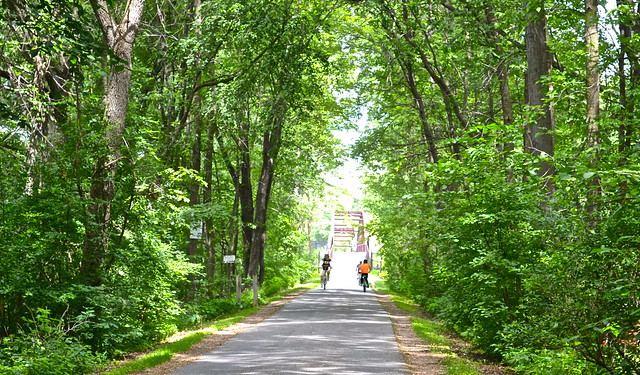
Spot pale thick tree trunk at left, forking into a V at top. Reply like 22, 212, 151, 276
80, 0, 144, 285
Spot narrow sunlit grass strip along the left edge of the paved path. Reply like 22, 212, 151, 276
100, 284, 318, 375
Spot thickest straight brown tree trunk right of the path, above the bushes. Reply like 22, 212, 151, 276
525, 1, 555, 193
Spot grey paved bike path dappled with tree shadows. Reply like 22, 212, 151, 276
171, 281, 407, 375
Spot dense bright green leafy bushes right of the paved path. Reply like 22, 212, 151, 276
370, 148, 640, 375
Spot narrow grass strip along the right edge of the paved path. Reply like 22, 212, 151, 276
375, 280, 482, 375
